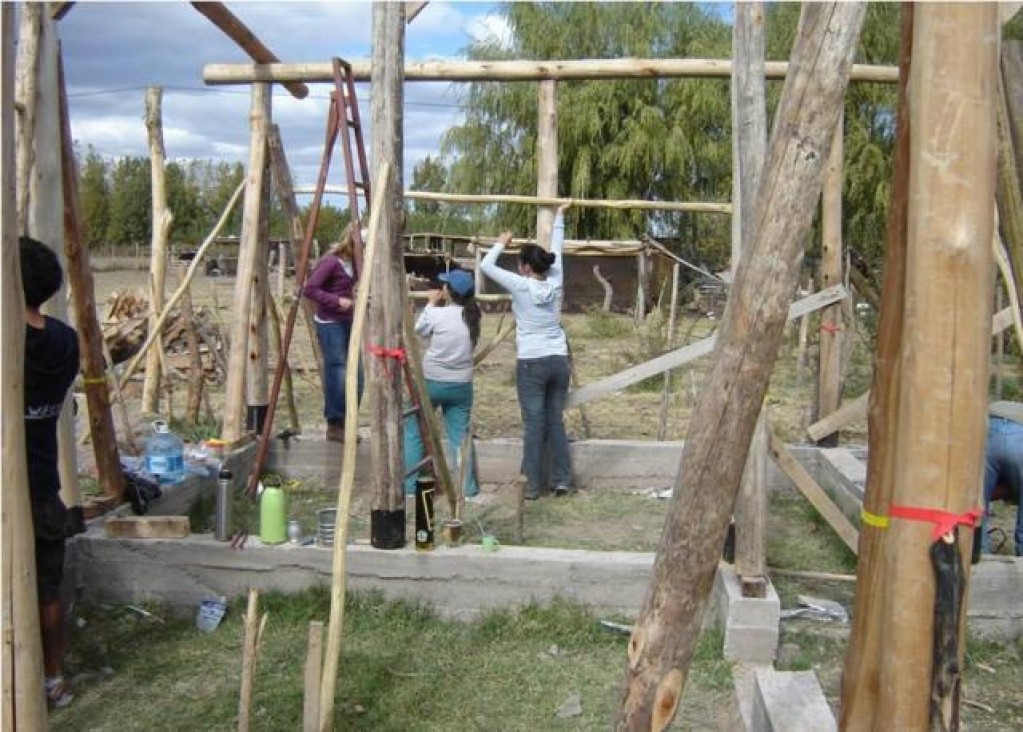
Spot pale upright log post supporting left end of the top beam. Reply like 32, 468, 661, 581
221, 84, 269, 443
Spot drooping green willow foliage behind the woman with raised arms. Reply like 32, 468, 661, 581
444, 3, 730, 251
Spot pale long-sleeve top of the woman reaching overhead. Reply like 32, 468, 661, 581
480, 213, 569, 359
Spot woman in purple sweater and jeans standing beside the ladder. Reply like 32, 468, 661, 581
302, 222, 362, 443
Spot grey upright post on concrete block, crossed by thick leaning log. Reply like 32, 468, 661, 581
731, 2, 769, 597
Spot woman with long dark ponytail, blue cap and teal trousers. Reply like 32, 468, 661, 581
405, 270, 482, 498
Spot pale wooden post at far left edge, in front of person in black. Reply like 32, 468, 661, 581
0, 3, 46, 730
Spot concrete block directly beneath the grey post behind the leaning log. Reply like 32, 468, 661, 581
714, 563, 782, 664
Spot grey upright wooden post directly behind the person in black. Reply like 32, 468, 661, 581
19, 8, 82, 506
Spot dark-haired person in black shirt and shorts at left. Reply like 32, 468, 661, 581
19, 236, 79, 706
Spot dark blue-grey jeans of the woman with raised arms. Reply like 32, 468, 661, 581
516, 356, 572, 496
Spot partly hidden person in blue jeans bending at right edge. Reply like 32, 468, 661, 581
981, 402, 1023, 556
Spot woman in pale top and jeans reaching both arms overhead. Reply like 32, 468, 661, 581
480, 203, 572, 501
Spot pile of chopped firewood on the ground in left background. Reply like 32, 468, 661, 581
101, 289, 227, 383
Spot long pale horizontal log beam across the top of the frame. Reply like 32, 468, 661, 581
203, 58, 898, 84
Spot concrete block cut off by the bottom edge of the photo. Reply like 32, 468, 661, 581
750, 668, 838, 732
